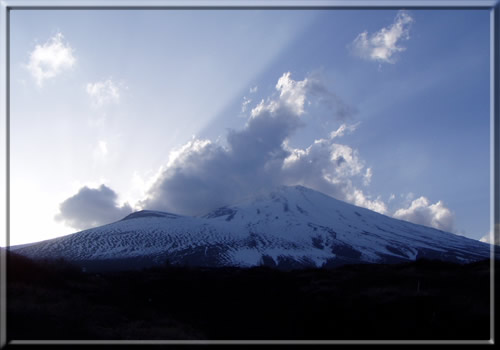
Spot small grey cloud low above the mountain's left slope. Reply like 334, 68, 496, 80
55, 185, 132, 230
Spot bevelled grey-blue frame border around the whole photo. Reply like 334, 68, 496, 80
0, 0, 500, 348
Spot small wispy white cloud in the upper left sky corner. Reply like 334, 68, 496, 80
26, 33, 76, 86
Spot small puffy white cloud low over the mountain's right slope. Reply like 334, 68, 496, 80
393, 196, 454, 232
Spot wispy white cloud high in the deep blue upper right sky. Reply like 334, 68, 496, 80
351, 11, 415, 63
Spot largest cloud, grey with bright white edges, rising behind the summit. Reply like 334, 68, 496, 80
140, 73, 363, 215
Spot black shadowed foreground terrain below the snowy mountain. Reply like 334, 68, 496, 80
7, 254, 490, 340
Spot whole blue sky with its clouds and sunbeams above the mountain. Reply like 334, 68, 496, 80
10, 10, 490, 244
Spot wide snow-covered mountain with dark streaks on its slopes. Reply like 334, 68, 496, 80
10, 186, 491, 269
